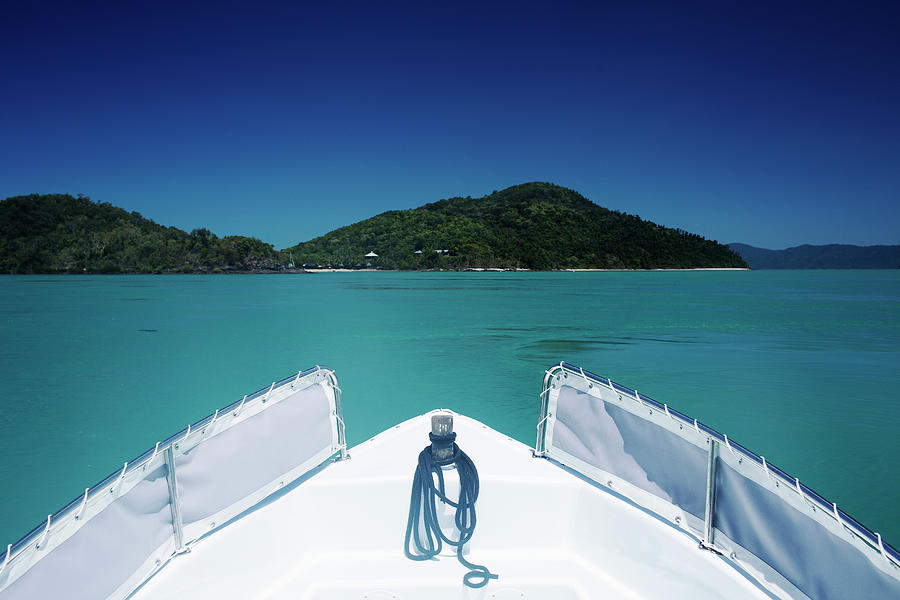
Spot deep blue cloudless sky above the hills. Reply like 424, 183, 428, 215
0, 0, 900, 248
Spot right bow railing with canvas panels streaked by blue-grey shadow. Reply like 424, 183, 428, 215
535, 363, 900, 600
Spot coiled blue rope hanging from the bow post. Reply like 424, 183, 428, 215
403, 433, 498, 588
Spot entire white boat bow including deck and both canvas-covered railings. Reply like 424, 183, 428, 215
0, 363, 900, 600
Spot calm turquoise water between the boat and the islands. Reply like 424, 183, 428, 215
0, 271, 900, 546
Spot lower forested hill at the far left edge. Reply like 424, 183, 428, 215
0, 194, 278, 273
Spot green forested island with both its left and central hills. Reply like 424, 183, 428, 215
0, 183, 747, 273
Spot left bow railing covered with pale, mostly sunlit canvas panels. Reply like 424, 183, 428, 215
0, 367, 347, 600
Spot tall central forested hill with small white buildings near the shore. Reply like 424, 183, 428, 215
288, 183, 747, 269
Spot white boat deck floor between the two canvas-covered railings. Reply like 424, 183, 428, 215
131, 415, 771, 600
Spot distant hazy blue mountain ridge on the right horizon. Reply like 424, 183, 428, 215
728, 243, 900, 269
